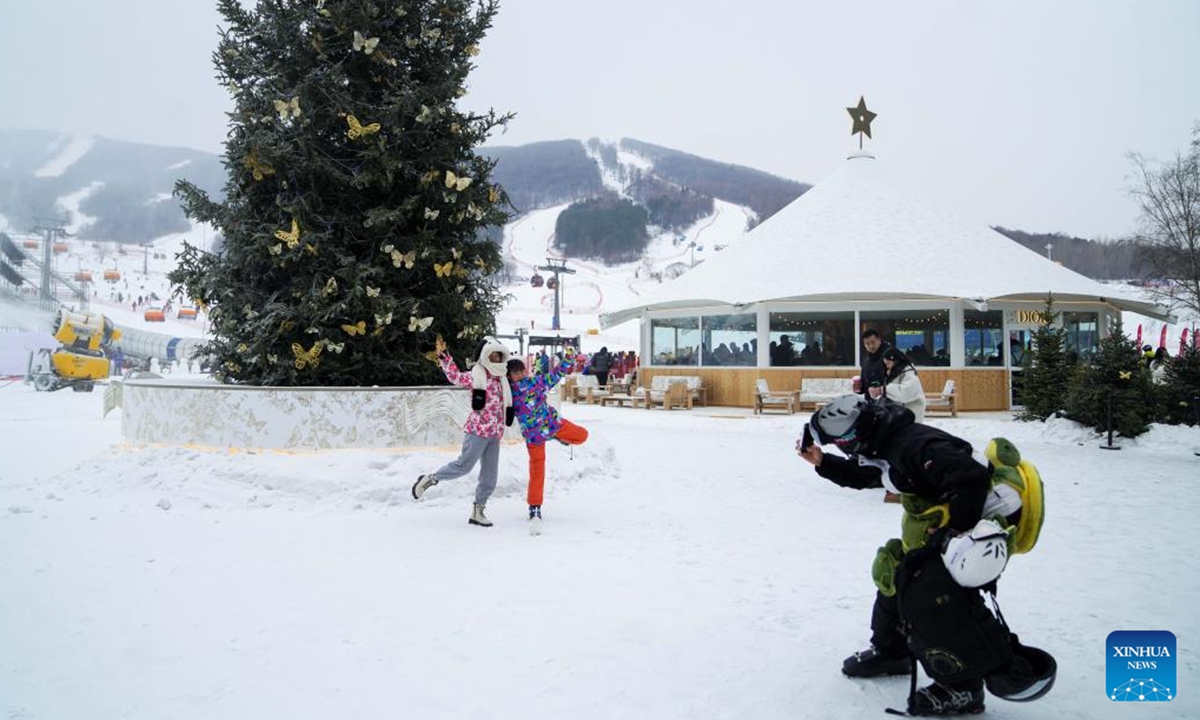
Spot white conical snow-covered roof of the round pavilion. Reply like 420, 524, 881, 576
600, 152, 1170, 328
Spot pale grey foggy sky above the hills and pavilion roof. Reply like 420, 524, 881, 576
0, 0, 1200, 238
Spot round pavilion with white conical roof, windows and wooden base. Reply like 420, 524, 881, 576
601, 152, 1170, 409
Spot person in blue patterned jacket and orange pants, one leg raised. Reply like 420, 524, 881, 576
508, 348, 589, 534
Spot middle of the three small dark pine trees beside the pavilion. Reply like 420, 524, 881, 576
1067, 320, 1154, 438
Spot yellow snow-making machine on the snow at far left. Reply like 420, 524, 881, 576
30, 310, 121, 392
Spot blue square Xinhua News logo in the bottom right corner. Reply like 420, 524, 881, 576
1105, 630, 1177, 702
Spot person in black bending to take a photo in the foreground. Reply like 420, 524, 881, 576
797, 395, 1054, 715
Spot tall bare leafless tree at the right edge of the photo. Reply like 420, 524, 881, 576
1129, 124, 1200, 314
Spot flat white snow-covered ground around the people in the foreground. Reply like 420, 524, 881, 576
0, 383, 1200, 720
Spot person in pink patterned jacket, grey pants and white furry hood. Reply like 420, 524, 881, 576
413, 337, 514, 528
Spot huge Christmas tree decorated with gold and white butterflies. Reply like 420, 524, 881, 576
170, 0, 510, 385
